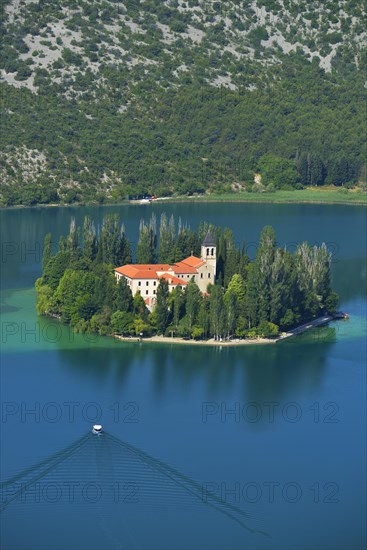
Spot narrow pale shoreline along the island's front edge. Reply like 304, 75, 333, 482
112, 315, 341, 347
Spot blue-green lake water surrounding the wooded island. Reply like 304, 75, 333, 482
1, 204, 366, 550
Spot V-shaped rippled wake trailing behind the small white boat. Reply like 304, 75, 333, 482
0, 432, 270, 537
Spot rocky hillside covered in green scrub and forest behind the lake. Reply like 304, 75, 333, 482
0, 0, 367, 205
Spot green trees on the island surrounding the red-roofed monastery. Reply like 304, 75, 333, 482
36, 214, 338, 339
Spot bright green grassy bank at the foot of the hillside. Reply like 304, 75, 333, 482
158, 187, 367, 205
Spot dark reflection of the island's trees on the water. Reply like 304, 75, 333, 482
58, 327, 337, 408
